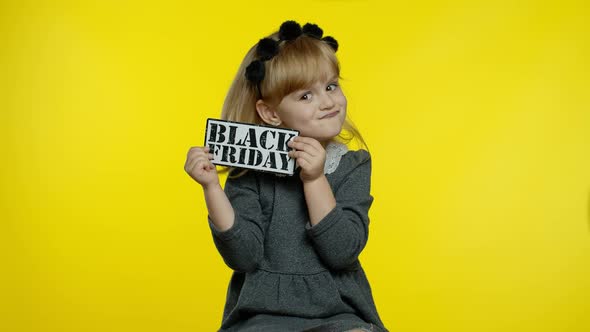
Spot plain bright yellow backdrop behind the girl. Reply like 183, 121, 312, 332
0, 0, 590, 332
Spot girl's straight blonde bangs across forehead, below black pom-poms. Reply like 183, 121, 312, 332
261, 37, 340, 102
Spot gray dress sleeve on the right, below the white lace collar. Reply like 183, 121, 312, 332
306, 150, 373, 270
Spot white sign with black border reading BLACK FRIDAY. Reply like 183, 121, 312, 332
205, 119, 299, 175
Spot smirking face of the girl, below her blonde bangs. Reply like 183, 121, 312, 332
277, 75, 346, 143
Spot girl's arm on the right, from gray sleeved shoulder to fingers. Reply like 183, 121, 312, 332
288, 136, 373, 270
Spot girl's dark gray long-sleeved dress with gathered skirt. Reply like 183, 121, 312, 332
209, 150, 387, 332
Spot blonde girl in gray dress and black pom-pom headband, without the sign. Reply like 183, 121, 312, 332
184, 21, 387, 332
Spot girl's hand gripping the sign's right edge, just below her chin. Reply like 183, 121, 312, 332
287, 136, 326, 183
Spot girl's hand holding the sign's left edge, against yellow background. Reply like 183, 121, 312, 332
184, 146, 219, 188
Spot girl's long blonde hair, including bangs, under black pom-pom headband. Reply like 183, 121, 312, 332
221, 32, 368, 176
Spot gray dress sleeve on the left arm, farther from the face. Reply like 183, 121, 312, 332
207, 171, 264, 272
